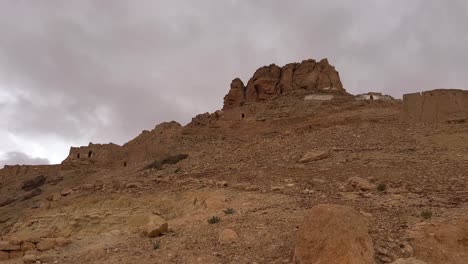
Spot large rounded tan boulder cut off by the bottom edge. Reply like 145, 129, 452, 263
294, 204, 375, 264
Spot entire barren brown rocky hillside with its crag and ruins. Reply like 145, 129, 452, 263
0, 60, 468, 264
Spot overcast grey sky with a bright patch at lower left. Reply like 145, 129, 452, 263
0, 0, 468, 167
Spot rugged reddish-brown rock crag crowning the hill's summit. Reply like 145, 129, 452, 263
223, 59, 346, 110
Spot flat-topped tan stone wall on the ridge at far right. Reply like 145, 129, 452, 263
402, 89, 468, 123
